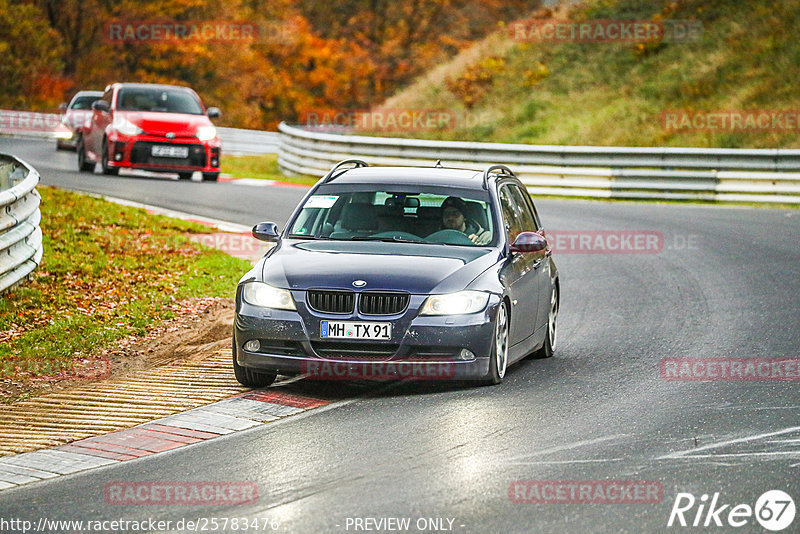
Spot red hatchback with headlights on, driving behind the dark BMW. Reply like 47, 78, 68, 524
77, 83, 221, 181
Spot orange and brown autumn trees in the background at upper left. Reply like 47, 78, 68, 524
6, 0, 539, 128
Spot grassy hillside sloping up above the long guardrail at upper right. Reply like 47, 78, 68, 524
380, 0, 800, 148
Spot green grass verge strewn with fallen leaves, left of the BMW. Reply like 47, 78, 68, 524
0, 187, 251, 386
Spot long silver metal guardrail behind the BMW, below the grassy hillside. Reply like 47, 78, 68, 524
278, 123, 800, 203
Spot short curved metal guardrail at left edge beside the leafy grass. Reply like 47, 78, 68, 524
0, 154, 43, 292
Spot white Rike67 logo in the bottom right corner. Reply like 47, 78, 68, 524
667, 490, 795, 532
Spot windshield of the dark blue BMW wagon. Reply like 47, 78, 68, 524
289, 191, 496, 246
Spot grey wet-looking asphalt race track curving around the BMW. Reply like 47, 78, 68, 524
0, 138, 800, 533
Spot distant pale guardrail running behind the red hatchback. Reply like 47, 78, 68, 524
0, 109, 280, 155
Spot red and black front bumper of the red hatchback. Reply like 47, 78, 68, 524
108, 133, 221, 173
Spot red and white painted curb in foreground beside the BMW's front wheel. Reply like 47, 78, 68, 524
0, 390, 331, 490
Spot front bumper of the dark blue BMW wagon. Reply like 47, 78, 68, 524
234, 292, 500, 380
